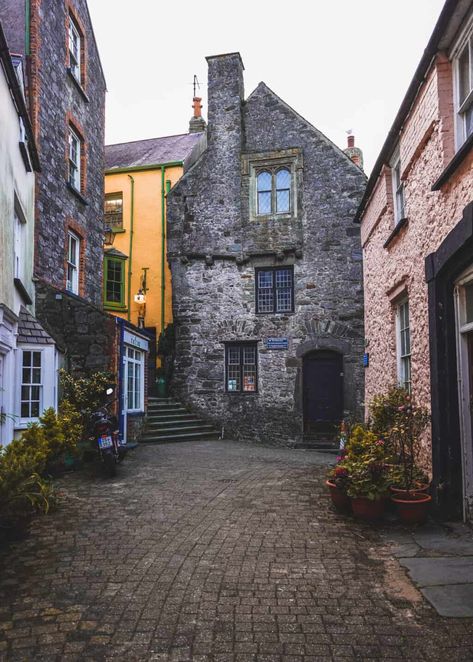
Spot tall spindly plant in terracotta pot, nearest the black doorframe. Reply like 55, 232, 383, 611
390, 398, 432, 524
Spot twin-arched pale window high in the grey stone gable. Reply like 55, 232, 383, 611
256, 168, 292, 216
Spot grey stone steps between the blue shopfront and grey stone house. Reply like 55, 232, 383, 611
141, 397, 220, 444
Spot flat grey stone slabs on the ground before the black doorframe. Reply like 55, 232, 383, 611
381, 523, 473, 618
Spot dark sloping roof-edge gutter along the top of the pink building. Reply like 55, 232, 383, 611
353, 0, 458, 223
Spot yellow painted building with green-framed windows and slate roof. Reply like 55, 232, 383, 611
104, 130, 204, 370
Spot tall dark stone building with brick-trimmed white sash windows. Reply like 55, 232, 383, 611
0, 0, 110, 369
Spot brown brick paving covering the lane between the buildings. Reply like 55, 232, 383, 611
0, 442, 473, 662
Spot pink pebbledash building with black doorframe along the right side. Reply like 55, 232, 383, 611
356, 0, 473, 520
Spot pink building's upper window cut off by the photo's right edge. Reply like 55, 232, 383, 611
455, 30, 473, 147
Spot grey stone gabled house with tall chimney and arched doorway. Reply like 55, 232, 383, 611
168, 53, 365, 444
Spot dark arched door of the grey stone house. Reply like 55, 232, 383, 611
302, 349, 343, 433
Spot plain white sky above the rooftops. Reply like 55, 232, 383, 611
88, 0, 444, 173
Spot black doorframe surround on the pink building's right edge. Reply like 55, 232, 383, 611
425, 203, 473, 519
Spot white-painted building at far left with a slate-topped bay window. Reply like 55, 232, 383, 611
0, 22, 57, 446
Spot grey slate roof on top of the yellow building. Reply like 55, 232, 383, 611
105, 133, 204, 170
